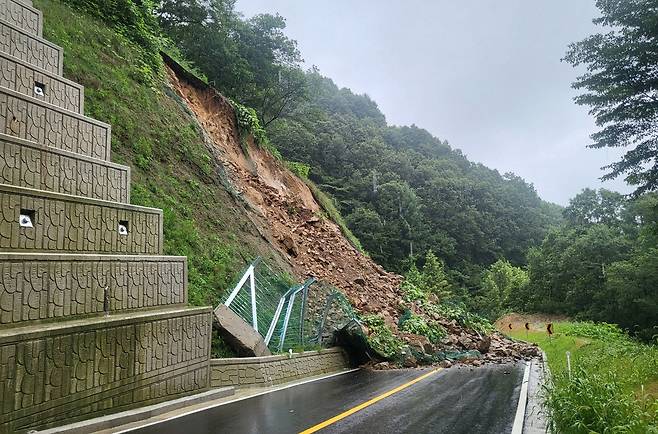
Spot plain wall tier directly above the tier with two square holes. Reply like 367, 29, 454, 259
0, 133, 130, 203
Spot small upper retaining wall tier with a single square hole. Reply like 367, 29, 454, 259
0, 50, 84, 114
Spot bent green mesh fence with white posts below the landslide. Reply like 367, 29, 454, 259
223, 258, 357, 352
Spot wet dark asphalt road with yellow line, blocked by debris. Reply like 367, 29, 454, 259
132, 364, 523, 434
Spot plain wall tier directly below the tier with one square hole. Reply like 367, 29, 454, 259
0, 88, 111, 161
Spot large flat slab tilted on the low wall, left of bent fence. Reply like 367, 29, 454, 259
214, 304, 272, 357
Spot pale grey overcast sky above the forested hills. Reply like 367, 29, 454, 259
237, 0, 630, 205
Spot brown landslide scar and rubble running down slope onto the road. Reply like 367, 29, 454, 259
168, 60, 538, 368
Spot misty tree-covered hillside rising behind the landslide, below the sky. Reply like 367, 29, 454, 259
159, 1, 560, 278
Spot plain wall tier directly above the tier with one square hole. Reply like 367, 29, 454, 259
0, 19, 63, 75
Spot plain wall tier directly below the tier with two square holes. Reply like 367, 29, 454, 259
0, 252, 187, 330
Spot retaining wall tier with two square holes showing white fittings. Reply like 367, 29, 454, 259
0, 184, 162, 255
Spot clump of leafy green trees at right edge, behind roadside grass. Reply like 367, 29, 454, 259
519, 190, 658, 341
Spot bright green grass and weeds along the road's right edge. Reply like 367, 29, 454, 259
508, 322, 658, 433
